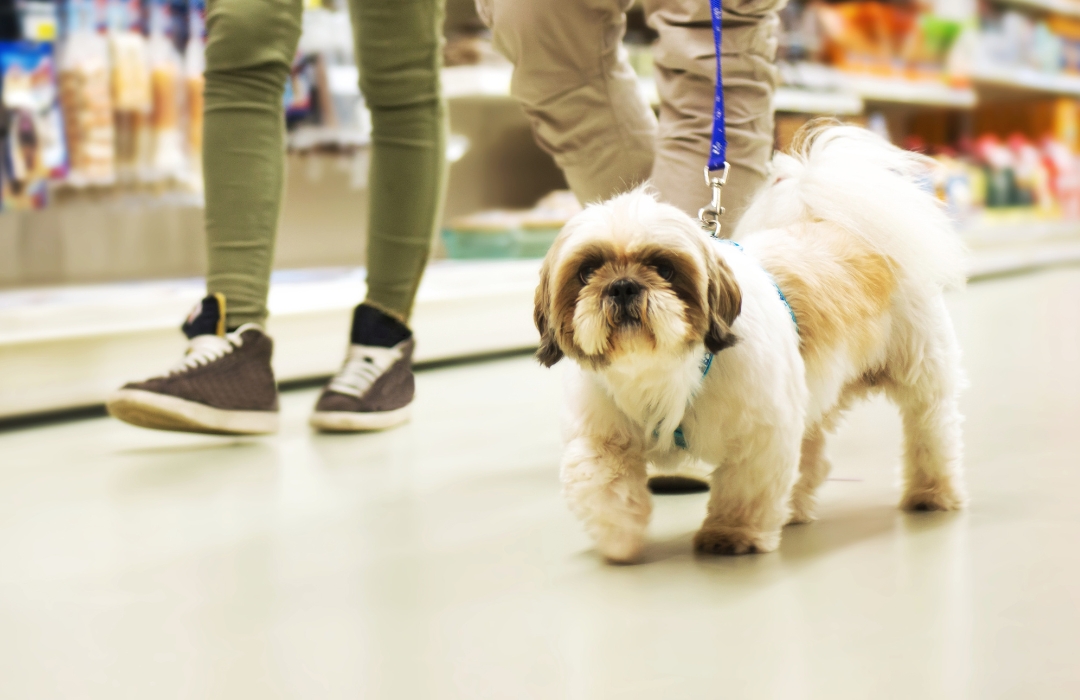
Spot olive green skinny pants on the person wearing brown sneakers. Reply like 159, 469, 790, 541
203, 0, 446, 328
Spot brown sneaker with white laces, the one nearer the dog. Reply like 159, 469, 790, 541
311, 304, 416, 432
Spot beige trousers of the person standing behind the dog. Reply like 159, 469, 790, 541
477, 0, 785, 226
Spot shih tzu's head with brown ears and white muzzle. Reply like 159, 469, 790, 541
534, 190, 742, 368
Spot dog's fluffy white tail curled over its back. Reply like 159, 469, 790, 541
735, 122, 966, 288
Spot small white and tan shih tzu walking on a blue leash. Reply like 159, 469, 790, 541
535, 125, 964, 562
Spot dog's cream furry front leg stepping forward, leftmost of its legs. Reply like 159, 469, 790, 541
562, 436, 652, 563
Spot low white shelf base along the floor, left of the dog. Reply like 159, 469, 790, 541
0, 260, 540, 418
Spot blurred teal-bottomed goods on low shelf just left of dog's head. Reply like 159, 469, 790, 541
443, 190, 581, 259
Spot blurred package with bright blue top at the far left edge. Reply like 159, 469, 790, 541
0, 41, 67, 210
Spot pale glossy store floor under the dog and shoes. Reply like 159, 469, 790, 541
0, 269, 1080, 700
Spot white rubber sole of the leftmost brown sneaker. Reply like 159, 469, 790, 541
105, 389, 278, 435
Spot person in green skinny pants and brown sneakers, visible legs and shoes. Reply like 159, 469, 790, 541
107, 0, 446, 434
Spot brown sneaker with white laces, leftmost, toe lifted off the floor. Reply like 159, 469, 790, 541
106, 295, 278, 435
